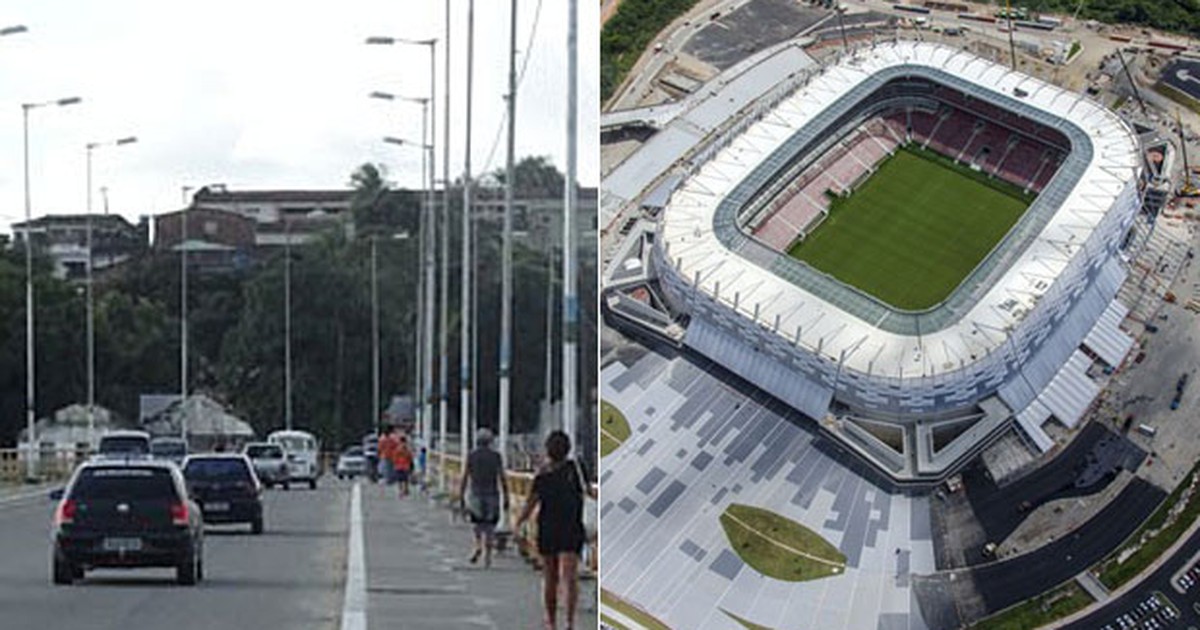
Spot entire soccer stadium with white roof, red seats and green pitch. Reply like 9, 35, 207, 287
648, 41, 1141, 484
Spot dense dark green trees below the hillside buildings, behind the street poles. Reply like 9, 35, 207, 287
0, 160, 596, 446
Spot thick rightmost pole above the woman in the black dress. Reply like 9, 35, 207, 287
563, 0, 580, 444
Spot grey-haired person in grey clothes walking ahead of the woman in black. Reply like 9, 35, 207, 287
458, 428, 509, 566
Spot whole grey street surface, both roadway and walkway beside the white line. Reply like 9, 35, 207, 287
0, 476, 596, 630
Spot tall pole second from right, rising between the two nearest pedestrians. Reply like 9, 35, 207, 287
499, 0, 517, 461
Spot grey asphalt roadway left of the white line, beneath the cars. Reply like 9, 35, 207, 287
0, 478, 349, 630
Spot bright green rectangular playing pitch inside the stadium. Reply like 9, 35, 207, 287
788, 142, 1034, 311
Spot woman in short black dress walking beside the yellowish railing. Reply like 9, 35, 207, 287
517, 431, 595, 630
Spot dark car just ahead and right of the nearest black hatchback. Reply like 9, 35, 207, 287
184, 452, 263, 534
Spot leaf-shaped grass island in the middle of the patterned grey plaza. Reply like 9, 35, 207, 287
721, 504, 846, 582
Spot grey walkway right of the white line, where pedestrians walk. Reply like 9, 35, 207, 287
362, 484, 598, 630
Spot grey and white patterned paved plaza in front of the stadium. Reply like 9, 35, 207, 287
600, 353, 934, 630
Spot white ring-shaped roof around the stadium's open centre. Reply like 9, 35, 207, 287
660, 42, 1140, 378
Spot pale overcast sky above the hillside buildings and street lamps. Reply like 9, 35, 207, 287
0, 0, 599, 226
